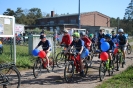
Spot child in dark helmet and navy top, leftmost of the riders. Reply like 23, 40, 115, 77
35, 34, 51, 69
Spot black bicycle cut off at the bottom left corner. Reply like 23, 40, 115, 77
0, 64, 21, 88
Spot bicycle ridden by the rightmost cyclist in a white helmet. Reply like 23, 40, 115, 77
114, 46, 124, 71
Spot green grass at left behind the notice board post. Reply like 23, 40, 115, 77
0, 45, 35, 69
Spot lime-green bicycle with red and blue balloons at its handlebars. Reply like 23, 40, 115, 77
99, 52, 114, 81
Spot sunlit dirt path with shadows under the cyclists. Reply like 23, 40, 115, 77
18, 54, 133, 88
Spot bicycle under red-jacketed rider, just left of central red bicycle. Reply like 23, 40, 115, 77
55, 45, 66, 68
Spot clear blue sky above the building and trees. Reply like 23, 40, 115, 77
0, 0, 131, 19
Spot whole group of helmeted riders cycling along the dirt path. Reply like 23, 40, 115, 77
36, 29, 127, 76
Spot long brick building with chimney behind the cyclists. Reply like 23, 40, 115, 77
25, 11, 110, 31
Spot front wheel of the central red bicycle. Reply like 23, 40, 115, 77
64, 61, 74, 83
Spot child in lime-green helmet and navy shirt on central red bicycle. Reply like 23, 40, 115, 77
65, 32, 89, 76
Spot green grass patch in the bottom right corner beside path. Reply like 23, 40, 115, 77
96, 66, 133, 88
